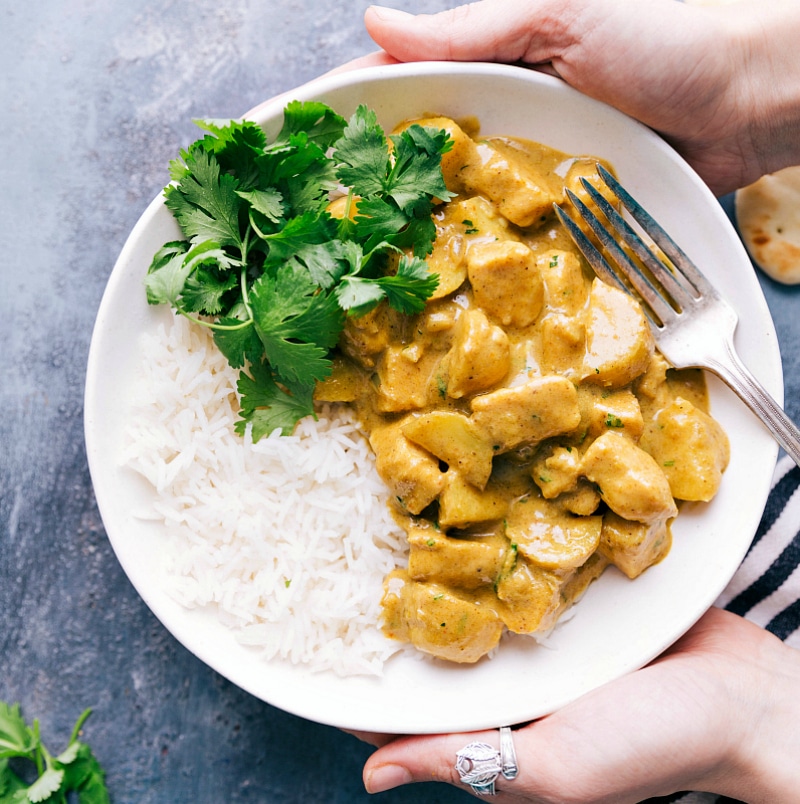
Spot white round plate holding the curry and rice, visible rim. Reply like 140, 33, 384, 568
85, 63, 783, 733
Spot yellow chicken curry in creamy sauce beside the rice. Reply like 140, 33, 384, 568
317, 118, 728, 662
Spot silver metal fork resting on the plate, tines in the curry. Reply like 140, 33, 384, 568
554, 165, 800, 466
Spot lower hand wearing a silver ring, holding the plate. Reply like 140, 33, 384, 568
359, 609, 800, 804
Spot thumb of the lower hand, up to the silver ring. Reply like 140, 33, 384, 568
364, 730, 522, 802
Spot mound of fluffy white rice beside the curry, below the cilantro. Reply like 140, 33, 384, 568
124, 316, 406, 675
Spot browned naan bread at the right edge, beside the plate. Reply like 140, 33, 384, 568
736, 165, 800, 285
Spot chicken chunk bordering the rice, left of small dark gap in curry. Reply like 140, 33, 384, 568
369, 423, 445, 514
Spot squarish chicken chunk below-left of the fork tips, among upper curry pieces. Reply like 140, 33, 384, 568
467, 240, 544, 327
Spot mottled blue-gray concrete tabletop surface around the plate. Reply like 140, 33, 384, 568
0, 0, 800, 804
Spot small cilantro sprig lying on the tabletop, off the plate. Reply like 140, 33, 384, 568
0, 701, 110, 804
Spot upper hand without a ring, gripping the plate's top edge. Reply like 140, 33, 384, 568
365, 0, 800, 194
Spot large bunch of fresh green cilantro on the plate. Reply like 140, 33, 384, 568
145, 101, 452, 440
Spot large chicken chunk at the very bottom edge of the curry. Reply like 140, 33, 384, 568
381, 570, 503, 663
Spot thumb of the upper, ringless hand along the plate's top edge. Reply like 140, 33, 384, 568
364, 0, 606, 64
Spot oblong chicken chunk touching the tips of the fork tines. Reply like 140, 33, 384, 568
461, 142, 557, 227
